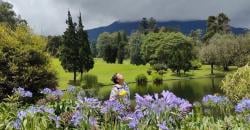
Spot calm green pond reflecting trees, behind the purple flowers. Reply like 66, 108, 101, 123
96, 78, 223, 102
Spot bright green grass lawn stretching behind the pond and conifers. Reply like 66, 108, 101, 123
51, 58, 236, 89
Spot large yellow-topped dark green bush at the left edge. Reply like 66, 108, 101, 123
0, 25, 57, 100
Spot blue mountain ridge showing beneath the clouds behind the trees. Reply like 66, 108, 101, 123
87, 20, 249, 41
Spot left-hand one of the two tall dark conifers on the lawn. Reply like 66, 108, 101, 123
59, 11, 78, 83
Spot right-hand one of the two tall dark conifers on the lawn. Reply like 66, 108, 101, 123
76, 13, 94, 78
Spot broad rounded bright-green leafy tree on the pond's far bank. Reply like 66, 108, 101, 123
142, 32, 193, 75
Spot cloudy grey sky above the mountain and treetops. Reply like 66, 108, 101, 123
5, 0, 250, 34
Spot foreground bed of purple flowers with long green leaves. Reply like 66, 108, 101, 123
0, 86, 250, 130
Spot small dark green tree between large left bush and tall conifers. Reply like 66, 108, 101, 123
46, 36, 63, 57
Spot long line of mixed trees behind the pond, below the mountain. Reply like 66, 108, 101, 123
95, 13, 250, 75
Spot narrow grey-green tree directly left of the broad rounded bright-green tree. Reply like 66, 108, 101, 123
129, 32, 146, 65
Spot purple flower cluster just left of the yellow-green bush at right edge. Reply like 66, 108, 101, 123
202, 95, 229, 104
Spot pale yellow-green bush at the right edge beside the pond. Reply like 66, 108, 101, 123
221, 65, 250, 102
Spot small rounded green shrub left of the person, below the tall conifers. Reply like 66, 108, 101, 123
82, 74, 98, 89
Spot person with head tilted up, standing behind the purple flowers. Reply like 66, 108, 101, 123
109, 73, 130, 104
